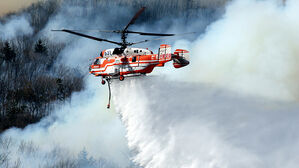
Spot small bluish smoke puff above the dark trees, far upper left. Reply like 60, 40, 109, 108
0, 15, 33, 40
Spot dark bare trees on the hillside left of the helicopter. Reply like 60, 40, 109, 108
0, 37, 84, 132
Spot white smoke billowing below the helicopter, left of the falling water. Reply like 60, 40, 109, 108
1, 77, 130, 167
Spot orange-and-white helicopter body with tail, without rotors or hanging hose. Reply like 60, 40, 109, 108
89, 44, 189, 79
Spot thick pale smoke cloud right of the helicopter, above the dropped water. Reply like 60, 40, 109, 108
191, 0, 299, 100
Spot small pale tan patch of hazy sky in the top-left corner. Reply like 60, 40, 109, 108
0, 0, 38, 16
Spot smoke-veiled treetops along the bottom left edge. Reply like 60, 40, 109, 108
0, 137, 140, 168
